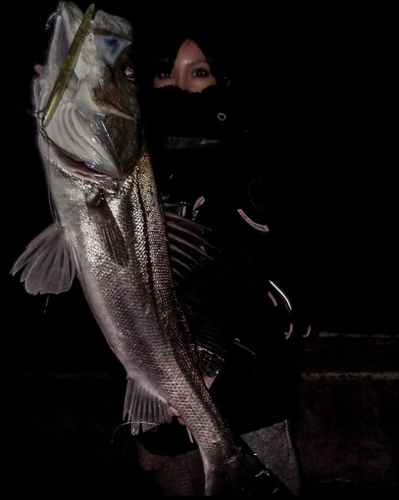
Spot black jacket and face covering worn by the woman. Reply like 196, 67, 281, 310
136, 86, 309, 453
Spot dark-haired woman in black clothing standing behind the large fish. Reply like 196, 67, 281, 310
128, 19, 316, 495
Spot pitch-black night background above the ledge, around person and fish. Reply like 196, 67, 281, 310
2, 1, 397, 373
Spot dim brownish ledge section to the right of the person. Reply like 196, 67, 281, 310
297, 334, 399, 495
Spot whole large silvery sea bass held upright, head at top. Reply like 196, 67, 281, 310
12, 2, 292, 495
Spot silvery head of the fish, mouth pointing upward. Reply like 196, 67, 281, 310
33, 2, 143, 180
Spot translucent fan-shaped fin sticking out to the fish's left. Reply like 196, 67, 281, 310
11, 223, 76, 295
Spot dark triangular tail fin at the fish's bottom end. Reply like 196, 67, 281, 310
205, 440, 294, 498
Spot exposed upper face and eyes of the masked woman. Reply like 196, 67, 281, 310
153, 40, 216, 92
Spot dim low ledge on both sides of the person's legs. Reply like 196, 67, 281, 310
1, 334, 399, 498
